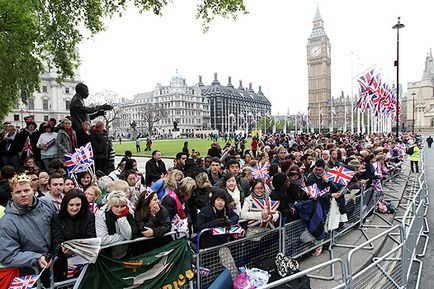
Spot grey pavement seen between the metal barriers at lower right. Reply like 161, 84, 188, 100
300, 159, 416, 289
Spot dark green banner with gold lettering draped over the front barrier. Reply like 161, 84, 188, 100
74, 238, 194, 289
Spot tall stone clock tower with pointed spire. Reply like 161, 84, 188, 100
306, 8, 331, 129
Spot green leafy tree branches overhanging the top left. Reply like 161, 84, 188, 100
0, 0, 247, 120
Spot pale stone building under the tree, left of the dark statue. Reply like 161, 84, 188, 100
5, 71, 81, 129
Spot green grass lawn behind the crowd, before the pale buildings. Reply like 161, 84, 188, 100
113, 139, 251, 157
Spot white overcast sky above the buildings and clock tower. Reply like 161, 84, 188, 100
80, 0, 434, 114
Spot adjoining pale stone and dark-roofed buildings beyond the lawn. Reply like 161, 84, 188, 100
113, 73, 271, 135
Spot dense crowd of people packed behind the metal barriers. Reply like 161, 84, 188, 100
0, 100, 420, 280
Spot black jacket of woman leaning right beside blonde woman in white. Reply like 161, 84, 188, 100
135, 206, 172, 238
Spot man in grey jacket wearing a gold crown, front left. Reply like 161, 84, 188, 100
0, 174, 55, 269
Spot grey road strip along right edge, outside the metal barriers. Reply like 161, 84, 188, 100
415, 146, 434, 288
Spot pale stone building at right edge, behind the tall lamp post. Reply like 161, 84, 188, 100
403, 49, 434, 132
